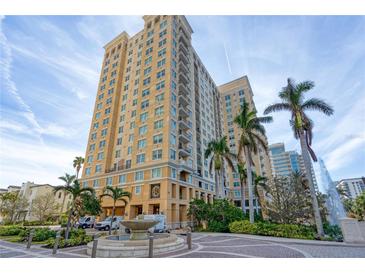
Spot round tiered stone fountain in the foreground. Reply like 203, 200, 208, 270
87, 215, 184, 258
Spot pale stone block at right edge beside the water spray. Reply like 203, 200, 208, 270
340, 218, 365, 244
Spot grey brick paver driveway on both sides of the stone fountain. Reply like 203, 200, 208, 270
0, 233, 365, 258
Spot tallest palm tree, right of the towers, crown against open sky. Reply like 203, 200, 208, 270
264, 78, 333, 236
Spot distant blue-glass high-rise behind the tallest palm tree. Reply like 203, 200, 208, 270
269, 143, 318, 190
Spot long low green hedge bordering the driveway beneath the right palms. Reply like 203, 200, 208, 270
229, 220, 316, 240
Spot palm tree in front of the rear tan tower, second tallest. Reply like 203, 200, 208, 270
234, 101, 272, 223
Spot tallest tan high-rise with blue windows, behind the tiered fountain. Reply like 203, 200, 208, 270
81, 16, 226, 228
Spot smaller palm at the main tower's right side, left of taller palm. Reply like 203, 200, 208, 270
204, 136, 236, 197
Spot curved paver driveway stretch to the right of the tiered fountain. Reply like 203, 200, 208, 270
159, 233, 365, 258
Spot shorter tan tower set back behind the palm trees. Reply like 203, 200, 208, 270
218, 76, 271, 208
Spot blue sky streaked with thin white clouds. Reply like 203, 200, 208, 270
0, 16, 365, 187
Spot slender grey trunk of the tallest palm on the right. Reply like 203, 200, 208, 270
299, 133, 324, 237
